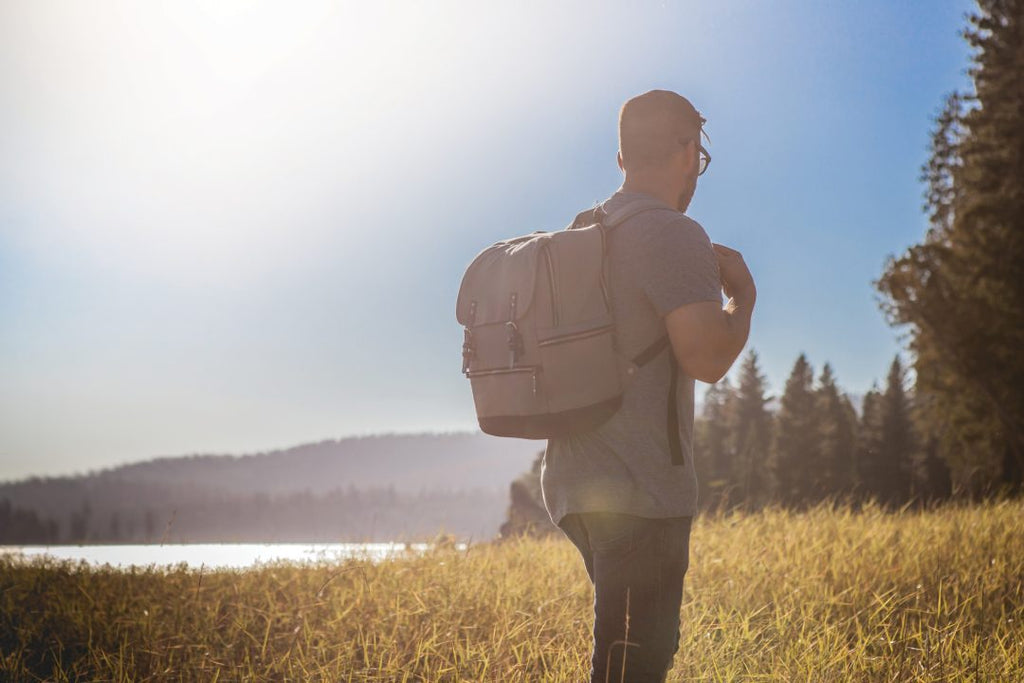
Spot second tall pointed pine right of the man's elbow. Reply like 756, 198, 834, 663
775, 353, 818, 506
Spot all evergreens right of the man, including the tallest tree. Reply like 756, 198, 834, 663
695, 0, 1024, 508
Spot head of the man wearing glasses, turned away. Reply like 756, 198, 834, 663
618, 90, 707, 211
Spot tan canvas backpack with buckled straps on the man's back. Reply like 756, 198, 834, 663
456, 200, 678, 440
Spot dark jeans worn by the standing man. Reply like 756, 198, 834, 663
559, 512, 691, 683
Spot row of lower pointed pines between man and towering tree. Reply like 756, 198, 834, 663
693, 349, 953, 509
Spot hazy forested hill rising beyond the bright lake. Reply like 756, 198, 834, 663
0, 433, 544, 542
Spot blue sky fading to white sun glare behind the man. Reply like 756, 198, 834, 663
0, 0, 972, 480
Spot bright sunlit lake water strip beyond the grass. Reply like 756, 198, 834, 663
0, 543, 456, 569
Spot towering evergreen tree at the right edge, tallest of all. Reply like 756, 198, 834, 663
877, 0, 1024, 492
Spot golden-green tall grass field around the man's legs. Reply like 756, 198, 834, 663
0, 501, 1024, 681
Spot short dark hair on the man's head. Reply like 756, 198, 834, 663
618, 90, 705, 169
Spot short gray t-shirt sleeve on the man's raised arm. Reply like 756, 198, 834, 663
641, 216, 722, 317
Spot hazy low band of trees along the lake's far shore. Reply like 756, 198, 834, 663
0, 486, 504, 545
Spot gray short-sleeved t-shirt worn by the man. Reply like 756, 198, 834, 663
541, 190, 722, 524
